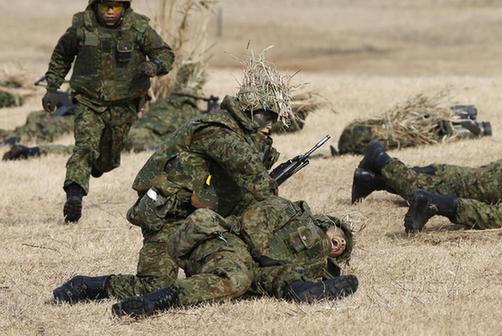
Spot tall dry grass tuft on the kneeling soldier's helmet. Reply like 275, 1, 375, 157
237, 47, 296, 125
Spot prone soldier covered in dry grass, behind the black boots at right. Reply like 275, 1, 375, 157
331, 95, 492, 156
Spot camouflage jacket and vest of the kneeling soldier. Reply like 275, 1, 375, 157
133, 96, 277, 216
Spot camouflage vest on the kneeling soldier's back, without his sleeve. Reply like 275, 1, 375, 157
133, 98, 260, 216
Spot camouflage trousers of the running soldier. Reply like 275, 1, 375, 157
64, 103, 137, 194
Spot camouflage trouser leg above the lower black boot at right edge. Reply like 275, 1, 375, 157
455, 198, 502, 230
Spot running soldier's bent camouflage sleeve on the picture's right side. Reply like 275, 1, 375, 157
142, 26, 174, 76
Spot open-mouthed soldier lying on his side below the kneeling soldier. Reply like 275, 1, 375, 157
54, 197, 358, 316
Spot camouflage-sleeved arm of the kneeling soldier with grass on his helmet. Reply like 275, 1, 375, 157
191, 127, 277, 203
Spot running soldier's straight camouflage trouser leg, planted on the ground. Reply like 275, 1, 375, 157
64, 104, 105, 195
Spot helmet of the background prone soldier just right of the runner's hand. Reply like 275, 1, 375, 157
173, 62, 206, 96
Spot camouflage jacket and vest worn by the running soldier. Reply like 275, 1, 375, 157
46, 6, 174, 105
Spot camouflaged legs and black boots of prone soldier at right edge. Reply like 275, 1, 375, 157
352, 141, 502, 232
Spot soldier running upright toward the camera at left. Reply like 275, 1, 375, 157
42, 0, 174, 222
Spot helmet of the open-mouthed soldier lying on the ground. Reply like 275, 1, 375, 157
314, 215, 354, 263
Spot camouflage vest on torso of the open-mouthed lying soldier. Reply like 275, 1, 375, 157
241, 197, 331, 278
